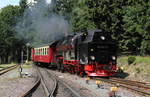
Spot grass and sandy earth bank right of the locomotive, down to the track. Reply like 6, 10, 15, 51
117, 56, 150, 83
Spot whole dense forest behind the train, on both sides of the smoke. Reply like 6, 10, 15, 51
0, 0, 150, 63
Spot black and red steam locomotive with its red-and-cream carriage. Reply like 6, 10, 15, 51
32, 30, 117, 77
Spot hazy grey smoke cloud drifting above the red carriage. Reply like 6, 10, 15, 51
16, 0, 70, 46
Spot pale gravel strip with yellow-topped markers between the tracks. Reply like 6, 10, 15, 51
50, 70, 144, 97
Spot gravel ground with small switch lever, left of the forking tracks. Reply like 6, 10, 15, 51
0, 65, 36, 97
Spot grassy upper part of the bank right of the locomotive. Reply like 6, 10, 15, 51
117, 56, 150, 76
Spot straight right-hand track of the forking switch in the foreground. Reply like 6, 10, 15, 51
38, 68, 82, 97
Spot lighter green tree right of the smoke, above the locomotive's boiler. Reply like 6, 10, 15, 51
56, 0, 96, 32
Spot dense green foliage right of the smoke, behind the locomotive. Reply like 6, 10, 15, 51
55, 0, 150, 55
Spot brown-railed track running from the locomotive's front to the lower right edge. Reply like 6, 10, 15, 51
97, 78, 150, 97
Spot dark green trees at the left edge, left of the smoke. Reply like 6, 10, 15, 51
0, 5, 22, 63
